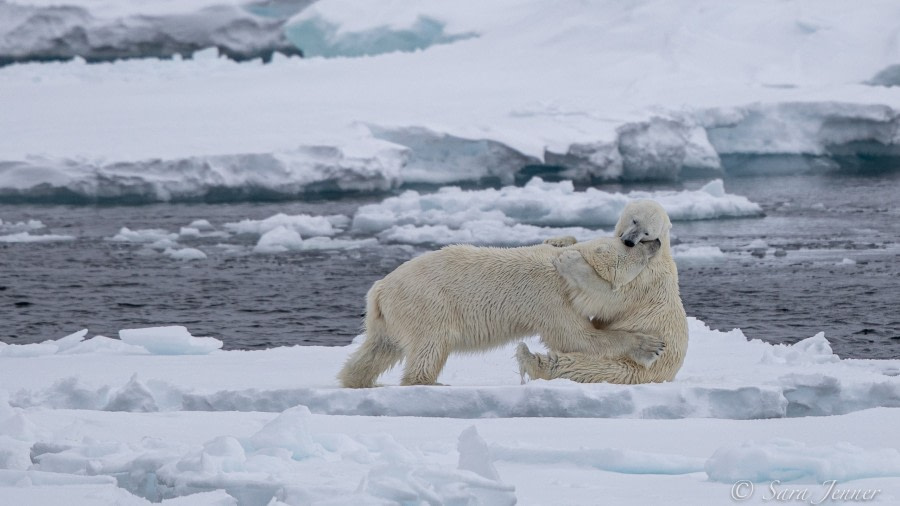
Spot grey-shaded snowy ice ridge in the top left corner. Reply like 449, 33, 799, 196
0, 0, 300, 65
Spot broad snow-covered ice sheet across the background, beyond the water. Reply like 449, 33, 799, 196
0, 0, 900, 202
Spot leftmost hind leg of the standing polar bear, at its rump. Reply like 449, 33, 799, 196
338, 281, 403, 388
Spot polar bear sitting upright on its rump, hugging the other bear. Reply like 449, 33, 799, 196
516, 200, 688, 384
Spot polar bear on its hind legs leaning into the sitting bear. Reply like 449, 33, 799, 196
338, 237, 664, 388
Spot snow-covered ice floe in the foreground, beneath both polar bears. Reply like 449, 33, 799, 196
0, 318, 900, 505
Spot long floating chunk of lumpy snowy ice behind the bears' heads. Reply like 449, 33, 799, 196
351, 178, 762, 244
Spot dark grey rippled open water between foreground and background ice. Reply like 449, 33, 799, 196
0, 172, 900, 358
